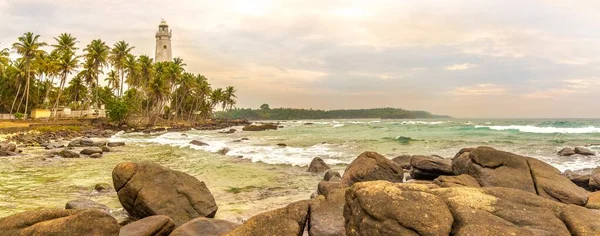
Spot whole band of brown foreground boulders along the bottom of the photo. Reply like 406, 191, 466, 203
0, 147, 600, 236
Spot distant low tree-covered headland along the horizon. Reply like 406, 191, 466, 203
215, 104, 448, 120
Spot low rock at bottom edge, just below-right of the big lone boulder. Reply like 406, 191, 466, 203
169, 217, 240, 236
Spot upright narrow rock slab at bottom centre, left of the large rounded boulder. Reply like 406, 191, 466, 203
308, 188, 347, 236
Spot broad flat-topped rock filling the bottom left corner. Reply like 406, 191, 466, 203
0, 209, 119, 236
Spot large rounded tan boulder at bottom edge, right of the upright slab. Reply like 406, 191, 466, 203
344, 181, 453, 236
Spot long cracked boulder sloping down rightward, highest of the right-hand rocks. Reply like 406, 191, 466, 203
452, 147, 587, 205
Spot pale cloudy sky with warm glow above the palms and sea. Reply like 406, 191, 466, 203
0, 0, 600, 118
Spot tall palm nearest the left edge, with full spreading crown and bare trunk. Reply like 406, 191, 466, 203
11, 32, 47, 119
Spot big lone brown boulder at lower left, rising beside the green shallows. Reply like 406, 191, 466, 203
113, 162, 217, 226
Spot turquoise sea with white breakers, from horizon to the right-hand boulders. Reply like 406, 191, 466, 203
113, 119, 600, 170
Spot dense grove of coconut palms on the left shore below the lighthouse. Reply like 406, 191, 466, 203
0, 32, 236, 123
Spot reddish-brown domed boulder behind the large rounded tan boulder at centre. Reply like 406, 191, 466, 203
341, 152, 404, 187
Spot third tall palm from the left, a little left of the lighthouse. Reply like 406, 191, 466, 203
83, 39, 110, 107
